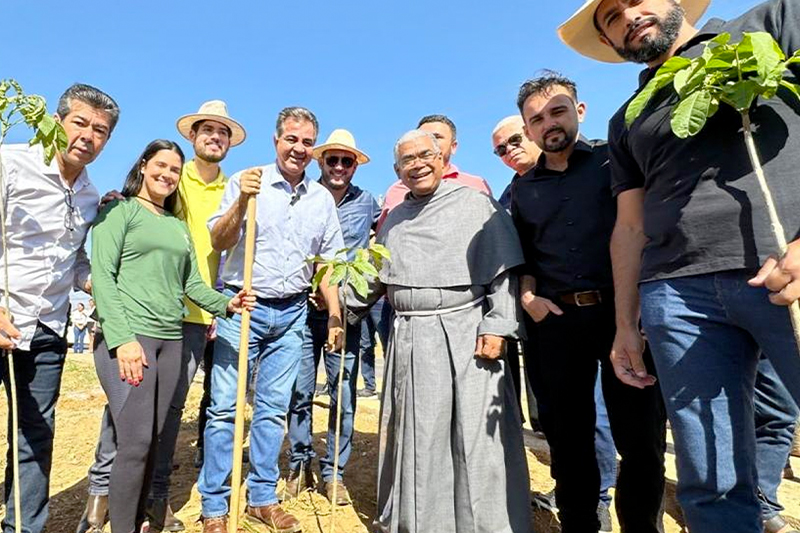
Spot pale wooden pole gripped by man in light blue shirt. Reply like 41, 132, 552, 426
228, 195, 256, 533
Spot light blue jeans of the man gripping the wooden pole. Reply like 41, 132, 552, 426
197, 289, 307, 518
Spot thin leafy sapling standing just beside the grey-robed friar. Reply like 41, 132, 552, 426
307, 244, 391, 533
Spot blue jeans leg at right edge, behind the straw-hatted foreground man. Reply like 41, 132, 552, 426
755, 355, 800, 520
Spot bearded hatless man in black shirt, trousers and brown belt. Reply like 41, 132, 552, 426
511, 74, 665, 533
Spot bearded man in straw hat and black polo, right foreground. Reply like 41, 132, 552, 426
559, 0, 800, 533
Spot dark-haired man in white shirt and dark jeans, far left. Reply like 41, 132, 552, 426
0, 84, 119, 533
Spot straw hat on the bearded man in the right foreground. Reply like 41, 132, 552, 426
558, 0, 711, 63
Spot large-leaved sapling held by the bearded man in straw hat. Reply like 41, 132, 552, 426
625, 32, 800, 348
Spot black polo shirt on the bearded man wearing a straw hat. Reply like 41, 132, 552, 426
608, 0, 800, 281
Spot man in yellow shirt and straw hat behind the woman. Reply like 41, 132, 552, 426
76, 100, 246, 533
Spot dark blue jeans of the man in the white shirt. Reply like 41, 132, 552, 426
0, 323, 67, 533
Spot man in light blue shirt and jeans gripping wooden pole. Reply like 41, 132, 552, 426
198, 107, 344, 533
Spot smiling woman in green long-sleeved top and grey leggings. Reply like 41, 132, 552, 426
92, 140, 255, 533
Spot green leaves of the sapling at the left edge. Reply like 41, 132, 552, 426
0, 79, 67, 165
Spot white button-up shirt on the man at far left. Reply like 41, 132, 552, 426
0, 144, 100, 350
